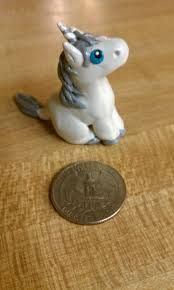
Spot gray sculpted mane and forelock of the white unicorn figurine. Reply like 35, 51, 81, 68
58, 30, 99, 109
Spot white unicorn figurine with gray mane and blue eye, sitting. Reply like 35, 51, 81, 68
15, 23, 129, 145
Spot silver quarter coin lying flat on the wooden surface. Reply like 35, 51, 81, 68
50, 161, 126, 225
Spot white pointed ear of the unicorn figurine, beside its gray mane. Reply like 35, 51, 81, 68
63, 42, 83, 67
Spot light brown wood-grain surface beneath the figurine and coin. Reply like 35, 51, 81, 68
0, 0, 174, 290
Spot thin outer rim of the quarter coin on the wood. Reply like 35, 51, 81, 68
49, 160, 127, 226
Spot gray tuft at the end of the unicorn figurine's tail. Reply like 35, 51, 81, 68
15, 93, 43, 118
